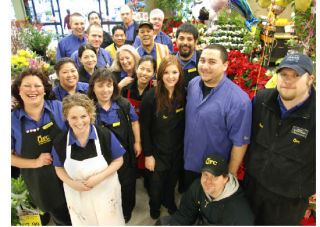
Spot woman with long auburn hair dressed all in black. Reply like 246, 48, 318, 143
140, 55, 185, 219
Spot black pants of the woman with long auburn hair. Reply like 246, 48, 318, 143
148, 168, 179, 210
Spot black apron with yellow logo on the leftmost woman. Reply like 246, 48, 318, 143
20, 112, 66, 212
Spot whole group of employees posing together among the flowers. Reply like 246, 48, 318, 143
11, 5, 316, 226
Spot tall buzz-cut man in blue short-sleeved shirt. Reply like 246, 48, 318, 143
184, 44, 252, 189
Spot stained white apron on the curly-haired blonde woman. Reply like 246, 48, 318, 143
63, 127, 125, 225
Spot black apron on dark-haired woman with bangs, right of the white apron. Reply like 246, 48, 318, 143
97, 107, 136, 186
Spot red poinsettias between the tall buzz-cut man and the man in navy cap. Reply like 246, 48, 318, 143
226, 50, 271, 99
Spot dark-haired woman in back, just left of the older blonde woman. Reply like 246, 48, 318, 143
78, 44, 100, 83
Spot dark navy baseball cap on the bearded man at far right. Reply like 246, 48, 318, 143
277, 53, 313, 76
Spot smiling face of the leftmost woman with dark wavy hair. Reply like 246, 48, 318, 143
19, 75, 45, 106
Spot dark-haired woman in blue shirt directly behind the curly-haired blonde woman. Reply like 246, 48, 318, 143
53, 58, 89, 101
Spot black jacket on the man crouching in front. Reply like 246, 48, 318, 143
169, 178, 254, 225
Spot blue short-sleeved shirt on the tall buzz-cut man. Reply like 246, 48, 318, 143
184, 75, 252, 172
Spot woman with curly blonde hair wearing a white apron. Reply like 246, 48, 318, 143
52, 93, 125, 226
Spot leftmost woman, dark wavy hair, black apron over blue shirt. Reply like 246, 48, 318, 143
11, 68, 71, 225
